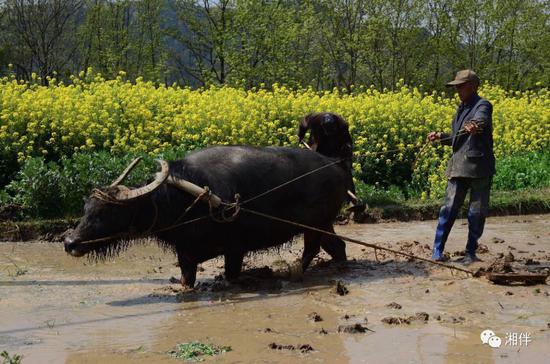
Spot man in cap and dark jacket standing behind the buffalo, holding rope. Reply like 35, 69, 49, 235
428, 70, 495, 265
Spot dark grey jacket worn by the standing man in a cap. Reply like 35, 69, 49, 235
441, 95, 495, 178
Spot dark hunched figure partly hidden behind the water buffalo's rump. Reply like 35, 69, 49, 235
298, 112, 358, 204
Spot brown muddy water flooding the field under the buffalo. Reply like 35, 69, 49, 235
0, 215, 550, 363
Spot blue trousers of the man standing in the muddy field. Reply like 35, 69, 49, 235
432, 177, 493, 259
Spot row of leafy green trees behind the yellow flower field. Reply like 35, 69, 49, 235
0, 0, 550, 91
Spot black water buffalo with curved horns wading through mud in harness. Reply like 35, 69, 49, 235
65, 146, 348, 287
